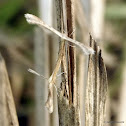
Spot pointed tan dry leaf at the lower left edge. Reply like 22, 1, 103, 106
0, 55, 19, 126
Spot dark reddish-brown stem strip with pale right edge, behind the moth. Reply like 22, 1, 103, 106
66, 0, 77, 106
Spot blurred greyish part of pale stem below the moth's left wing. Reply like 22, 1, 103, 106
34, 28, 49, 126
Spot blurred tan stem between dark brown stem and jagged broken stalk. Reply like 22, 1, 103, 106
75, 0, 89, 126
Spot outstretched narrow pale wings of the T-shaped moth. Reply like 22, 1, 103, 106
25, 14, 94, 55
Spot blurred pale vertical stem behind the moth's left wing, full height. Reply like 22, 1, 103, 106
35, 0, 53, 126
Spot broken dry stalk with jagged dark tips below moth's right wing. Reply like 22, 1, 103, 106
85, 36, 108, 126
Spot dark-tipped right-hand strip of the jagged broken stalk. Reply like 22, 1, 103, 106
98, 50, 108, 126
